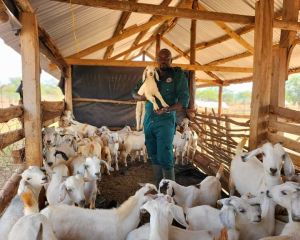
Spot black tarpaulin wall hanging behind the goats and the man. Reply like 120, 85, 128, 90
72, 63, 190, 127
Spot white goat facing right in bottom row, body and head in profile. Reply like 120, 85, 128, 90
186, 196, 261, 240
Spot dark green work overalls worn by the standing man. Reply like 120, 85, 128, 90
133, 67, 189, 170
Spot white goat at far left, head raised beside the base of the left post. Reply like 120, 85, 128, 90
0, 166, 47, 239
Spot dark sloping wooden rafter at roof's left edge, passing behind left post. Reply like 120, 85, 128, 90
16, 0, 68, 73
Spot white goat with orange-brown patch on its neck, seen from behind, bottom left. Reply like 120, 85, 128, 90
8, 189, 57, 240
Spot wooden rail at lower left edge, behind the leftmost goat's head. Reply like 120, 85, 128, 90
0, 166, 25, 215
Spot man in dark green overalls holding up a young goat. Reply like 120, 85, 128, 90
132, 49, 189, 186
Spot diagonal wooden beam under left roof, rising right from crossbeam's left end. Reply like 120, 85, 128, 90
67, 16, 170, 58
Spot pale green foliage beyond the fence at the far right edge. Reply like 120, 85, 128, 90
285, 74, 300, 105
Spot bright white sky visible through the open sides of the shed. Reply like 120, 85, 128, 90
0, 38, 252, 92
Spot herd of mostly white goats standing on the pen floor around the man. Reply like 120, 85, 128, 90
0, 112, 300, 240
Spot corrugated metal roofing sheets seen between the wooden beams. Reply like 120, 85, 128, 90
0, 0, 300, 83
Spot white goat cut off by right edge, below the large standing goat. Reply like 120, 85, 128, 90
268, 182, 300, 239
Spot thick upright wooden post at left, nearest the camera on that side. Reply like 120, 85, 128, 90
20, 12, 42, 166
